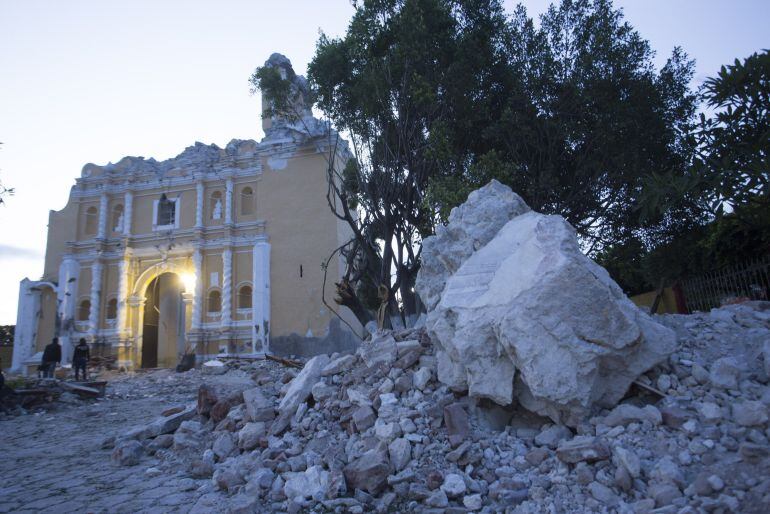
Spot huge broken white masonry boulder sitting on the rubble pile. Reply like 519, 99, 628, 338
417, 182, 676, 426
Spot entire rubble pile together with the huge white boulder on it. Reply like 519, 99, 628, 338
107, 183, 770, 514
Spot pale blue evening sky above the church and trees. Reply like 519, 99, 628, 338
0, 0, 770, 324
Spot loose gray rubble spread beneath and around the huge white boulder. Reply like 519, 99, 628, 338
109, 303, 770, 513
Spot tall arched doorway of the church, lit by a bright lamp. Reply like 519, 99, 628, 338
141, 272, 185, 368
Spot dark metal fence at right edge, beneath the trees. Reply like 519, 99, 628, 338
682, 255, 770, 312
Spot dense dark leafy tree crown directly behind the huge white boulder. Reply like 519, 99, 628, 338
434, 0, 696, 252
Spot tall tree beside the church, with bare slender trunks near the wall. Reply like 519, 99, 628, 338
308, 0, 507, 325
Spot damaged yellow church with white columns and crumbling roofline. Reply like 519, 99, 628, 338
13, 54, 355, 371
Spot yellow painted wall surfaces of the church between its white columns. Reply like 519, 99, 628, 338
22, 129, 356, 366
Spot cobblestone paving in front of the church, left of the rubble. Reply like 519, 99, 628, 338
0, 370, 208, 513
